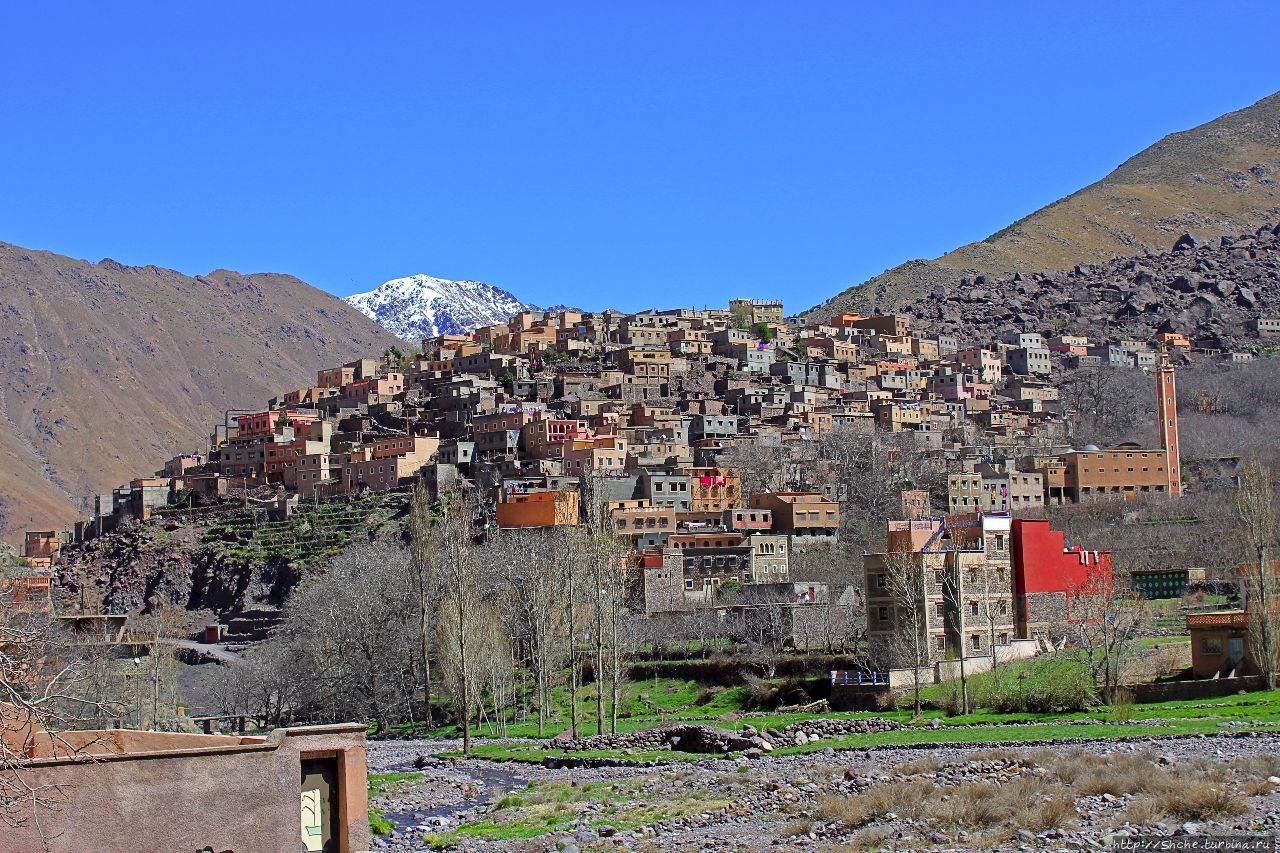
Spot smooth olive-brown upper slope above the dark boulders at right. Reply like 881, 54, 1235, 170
813, 93, 1280, 314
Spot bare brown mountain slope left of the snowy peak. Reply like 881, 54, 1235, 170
0, 243, 397, 543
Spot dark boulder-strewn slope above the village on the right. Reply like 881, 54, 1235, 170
901, 225, 1280, 350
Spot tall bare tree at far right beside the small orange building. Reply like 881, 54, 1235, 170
1235, 456, 1280, 688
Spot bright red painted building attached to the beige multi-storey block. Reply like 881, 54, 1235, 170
1012, 519, 1111, 638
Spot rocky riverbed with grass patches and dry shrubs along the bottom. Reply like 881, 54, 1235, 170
369, 733, 1280, 852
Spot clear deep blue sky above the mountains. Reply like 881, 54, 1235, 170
0, 1, 1280, 310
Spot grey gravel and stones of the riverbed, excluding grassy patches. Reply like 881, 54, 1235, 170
369, 731, 1280, 853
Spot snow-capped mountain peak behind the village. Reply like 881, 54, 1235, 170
347, 275, 532, 341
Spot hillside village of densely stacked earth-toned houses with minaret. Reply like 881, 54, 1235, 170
15, 225, 1280, 679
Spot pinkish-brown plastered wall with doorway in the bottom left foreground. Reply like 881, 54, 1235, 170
8, 725, 369, 853
